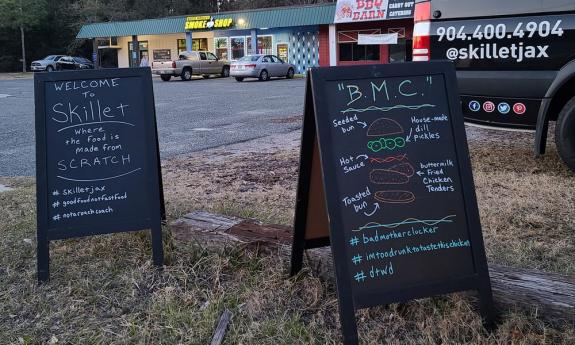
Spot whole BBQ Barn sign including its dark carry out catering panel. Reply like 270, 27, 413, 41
334, 0, 415, 23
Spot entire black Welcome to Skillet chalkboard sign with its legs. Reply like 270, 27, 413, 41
34, 68, 163, 281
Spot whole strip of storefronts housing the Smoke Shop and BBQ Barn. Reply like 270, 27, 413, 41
77, 0, 414, 73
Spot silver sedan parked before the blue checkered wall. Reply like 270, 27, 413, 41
230, 55, 295, 81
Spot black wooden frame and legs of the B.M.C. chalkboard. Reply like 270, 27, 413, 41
291, 62, 495, 344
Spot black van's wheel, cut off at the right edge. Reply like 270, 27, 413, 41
555, 97, 575, 172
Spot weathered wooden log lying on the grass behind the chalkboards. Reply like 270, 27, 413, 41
170, 211, 575, 323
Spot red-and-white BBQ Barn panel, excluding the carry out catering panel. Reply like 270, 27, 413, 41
334, 0, 388, 23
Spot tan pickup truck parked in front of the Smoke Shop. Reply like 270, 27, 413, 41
152, 51, 230, 81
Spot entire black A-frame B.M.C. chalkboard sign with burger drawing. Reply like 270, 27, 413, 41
291, 62, 493, 344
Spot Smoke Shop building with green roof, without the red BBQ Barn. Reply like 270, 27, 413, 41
77, 4, 335, 73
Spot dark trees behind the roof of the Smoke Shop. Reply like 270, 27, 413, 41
0, 0, 334, 72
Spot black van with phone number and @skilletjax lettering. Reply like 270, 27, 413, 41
413, 0, 575, 171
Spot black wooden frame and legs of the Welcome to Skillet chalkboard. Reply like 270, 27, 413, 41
34, 68, 165, 282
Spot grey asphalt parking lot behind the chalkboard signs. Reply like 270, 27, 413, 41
0, 78, 305, 176
